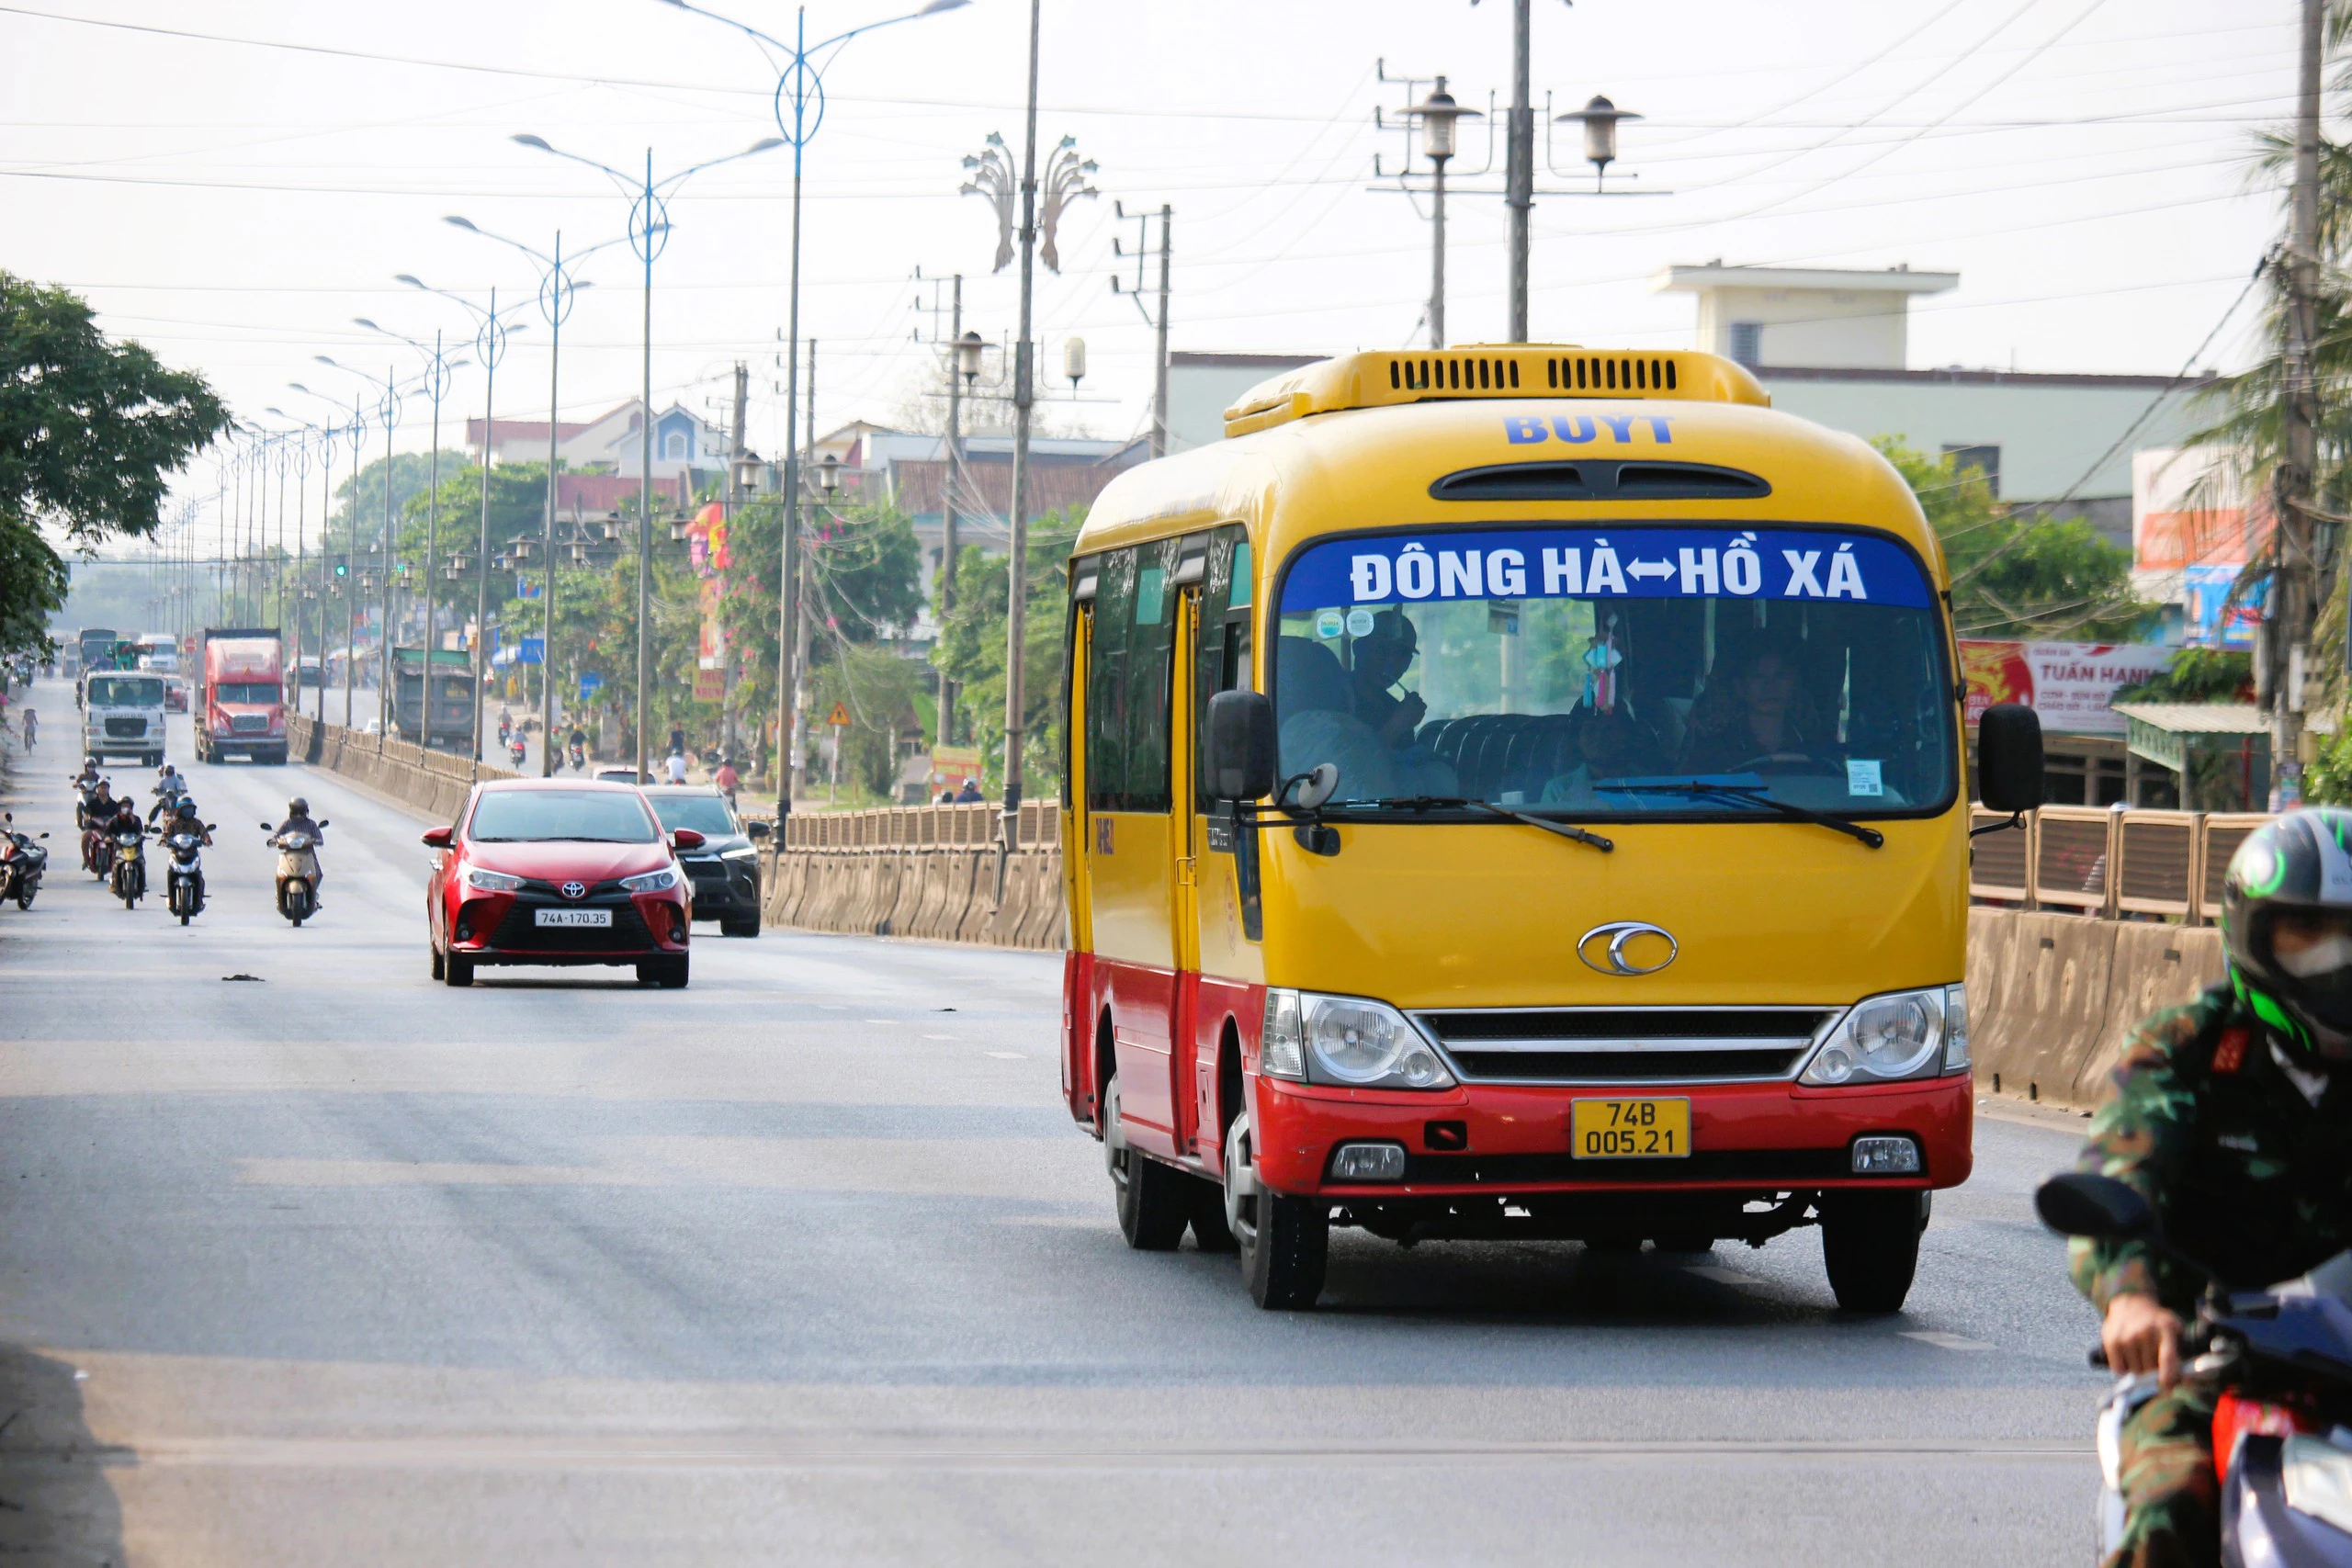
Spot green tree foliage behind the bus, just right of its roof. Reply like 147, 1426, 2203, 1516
1872, 434, 2150, 642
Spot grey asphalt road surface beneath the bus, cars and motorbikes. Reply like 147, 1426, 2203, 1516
0, 686, 2100, 1568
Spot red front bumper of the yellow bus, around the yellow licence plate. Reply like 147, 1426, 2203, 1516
1253, 1072, 1975, 1203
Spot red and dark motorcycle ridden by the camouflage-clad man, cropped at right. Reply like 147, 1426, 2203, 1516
2034, 1170, 2352, 1568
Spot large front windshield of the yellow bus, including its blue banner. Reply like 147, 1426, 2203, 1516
1272, 526, 1954, 818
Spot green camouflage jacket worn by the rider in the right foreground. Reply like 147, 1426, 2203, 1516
2067, 983, 2352, 1316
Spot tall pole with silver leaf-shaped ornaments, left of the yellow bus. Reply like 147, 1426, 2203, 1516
962, 64, 1093, 860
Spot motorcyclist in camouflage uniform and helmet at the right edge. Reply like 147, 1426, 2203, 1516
2070, 808, 2352, 1568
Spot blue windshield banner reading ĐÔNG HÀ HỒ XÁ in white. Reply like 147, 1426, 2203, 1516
1282, 526, 1931, 611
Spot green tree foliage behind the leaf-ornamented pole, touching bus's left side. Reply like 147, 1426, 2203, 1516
932, 510, 1084, 799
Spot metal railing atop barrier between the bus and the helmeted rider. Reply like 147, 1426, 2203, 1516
1969, 807, 2269, 926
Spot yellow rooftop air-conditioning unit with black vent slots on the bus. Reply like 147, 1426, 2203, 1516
1226, 344, 1771, 437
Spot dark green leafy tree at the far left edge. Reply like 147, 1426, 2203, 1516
0, 273, 228, 651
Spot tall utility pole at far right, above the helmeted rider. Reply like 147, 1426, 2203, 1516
2265, 0, 2324, 811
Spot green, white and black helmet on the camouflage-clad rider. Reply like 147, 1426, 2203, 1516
2221, 807, 2352, 1060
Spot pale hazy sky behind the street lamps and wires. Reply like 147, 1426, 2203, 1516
0, 0, 2296, 540
